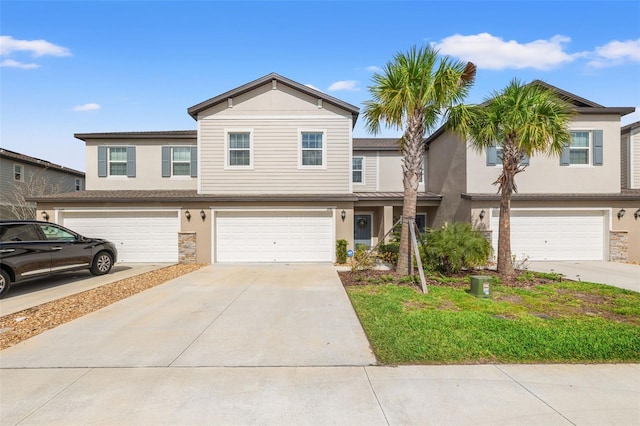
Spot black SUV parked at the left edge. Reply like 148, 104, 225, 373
0, 220, 117, 298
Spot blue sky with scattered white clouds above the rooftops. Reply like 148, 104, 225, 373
0, 0, 640, 170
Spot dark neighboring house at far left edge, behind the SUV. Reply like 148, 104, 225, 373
0, 148, 85, 219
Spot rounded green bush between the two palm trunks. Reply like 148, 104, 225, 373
420, 222, 492, 274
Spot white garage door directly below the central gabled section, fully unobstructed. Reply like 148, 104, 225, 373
215, 211, 335, 262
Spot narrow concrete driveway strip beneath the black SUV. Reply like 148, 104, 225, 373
0, 263, 172, 316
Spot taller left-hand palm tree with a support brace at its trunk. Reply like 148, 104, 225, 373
364, 46, 476, 275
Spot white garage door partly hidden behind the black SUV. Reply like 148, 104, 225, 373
63, 210, 180, 263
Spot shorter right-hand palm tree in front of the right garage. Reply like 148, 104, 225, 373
447, 79, 574, 277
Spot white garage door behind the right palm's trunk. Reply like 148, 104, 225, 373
491, 209, 605, 260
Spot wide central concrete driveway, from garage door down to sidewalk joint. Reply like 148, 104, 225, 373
0, 264, 375, 368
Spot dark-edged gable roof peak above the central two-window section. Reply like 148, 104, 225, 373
187, 73, 360, 125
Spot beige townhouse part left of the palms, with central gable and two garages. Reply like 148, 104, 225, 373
33, 74, 440, 263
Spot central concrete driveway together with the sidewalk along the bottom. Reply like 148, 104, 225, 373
0, 265, 640, 426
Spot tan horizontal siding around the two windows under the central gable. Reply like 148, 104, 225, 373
200, 116, 351, 194
